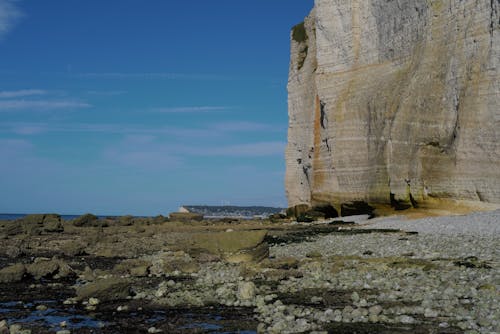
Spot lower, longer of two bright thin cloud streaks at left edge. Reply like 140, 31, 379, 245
0, 100, 91, 112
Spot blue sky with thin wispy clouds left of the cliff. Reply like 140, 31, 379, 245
0, 0, 313, 215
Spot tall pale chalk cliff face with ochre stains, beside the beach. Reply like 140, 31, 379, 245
285, 0, 500, 210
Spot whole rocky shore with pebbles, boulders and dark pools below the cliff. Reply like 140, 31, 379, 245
0, 211, 500, 334
